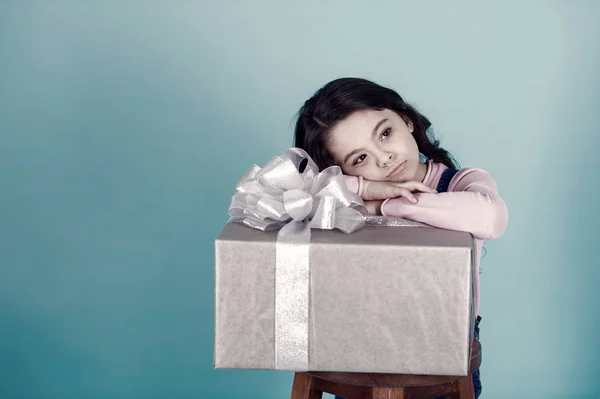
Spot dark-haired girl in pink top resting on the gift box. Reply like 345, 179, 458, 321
295, 78, 508, 399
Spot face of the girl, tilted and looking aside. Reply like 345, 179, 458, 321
327, 109, 427, 182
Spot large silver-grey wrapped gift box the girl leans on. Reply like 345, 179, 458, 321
214, 223, 475, 376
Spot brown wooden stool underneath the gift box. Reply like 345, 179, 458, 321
291, 341, 481, 399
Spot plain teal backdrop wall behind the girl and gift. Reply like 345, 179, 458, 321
0, 0, 600, 399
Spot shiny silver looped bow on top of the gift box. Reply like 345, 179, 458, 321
229, 148, 365, 239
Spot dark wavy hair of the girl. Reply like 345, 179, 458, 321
294, 78, 458, 170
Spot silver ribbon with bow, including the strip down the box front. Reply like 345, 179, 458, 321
229, 148, 419, 370
